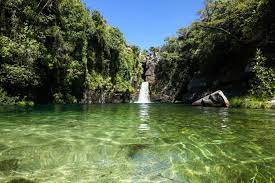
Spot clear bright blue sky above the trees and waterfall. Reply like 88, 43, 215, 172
82, 0, 204, 49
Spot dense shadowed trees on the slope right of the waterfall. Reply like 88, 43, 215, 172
152, 0, 275, 103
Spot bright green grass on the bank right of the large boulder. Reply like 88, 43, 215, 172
229, 96, 274, 109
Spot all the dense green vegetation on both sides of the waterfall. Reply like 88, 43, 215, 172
0, 0, 275, 105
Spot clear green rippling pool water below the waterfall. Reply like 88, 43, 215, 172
0, 104, 275, 183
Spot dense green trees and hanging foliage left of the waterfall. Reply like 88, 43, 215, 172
0, 0, 142, 104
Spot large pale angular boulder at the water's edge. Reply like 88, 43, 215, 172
192, 90, 229, 107
